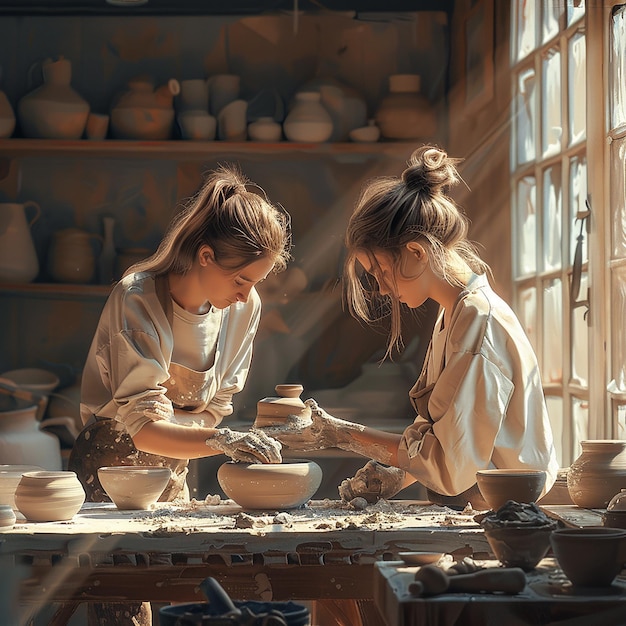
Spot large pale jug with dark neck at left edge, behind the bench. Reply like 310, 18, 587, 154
0, 394, 62, 470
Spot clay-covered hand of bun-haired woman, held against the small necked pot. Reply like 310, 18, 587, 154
260, 399, 346, 450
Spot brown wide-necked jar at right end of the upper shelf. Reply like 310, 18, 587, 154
375, 74, 437, 139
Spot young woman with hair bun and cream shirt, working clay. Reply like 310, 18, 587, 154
264, 146, 558, 508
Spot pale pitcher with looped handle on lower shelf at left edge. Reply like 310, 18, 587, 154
0, 200, 41, 283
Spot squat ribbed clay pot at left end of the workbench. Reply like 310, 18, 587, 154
15, 471, 85, 522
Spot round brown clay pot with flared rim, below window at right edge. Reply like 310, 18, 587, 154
567, 439, 626, 509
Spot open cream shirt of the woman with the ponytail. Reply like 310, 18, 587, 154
81, 272, 261, 437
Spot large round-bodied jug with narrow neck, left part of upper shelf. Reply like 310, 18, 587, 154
17, 56, 90, 139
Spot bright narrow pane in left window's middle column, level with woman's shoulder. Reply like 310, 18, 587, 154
541, 279, 563, 383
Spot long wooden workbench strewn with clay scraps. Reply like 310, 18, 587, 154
0, 500, 489, 626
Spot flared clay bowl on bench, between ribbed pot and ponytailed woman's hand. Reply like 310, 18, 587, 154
98, 465, 172, 510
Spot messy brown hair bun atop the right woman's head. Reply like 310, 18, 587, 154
402, 145, 459, 195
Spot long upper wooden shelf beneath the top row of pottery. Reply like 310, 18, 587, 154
0, 139, 417, 160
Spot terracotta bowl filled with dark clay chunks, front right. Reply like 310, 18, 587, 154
485, 524, 556, 572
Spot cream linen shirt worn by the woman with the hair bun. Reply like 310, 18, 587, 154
398, 276, 558, 496
